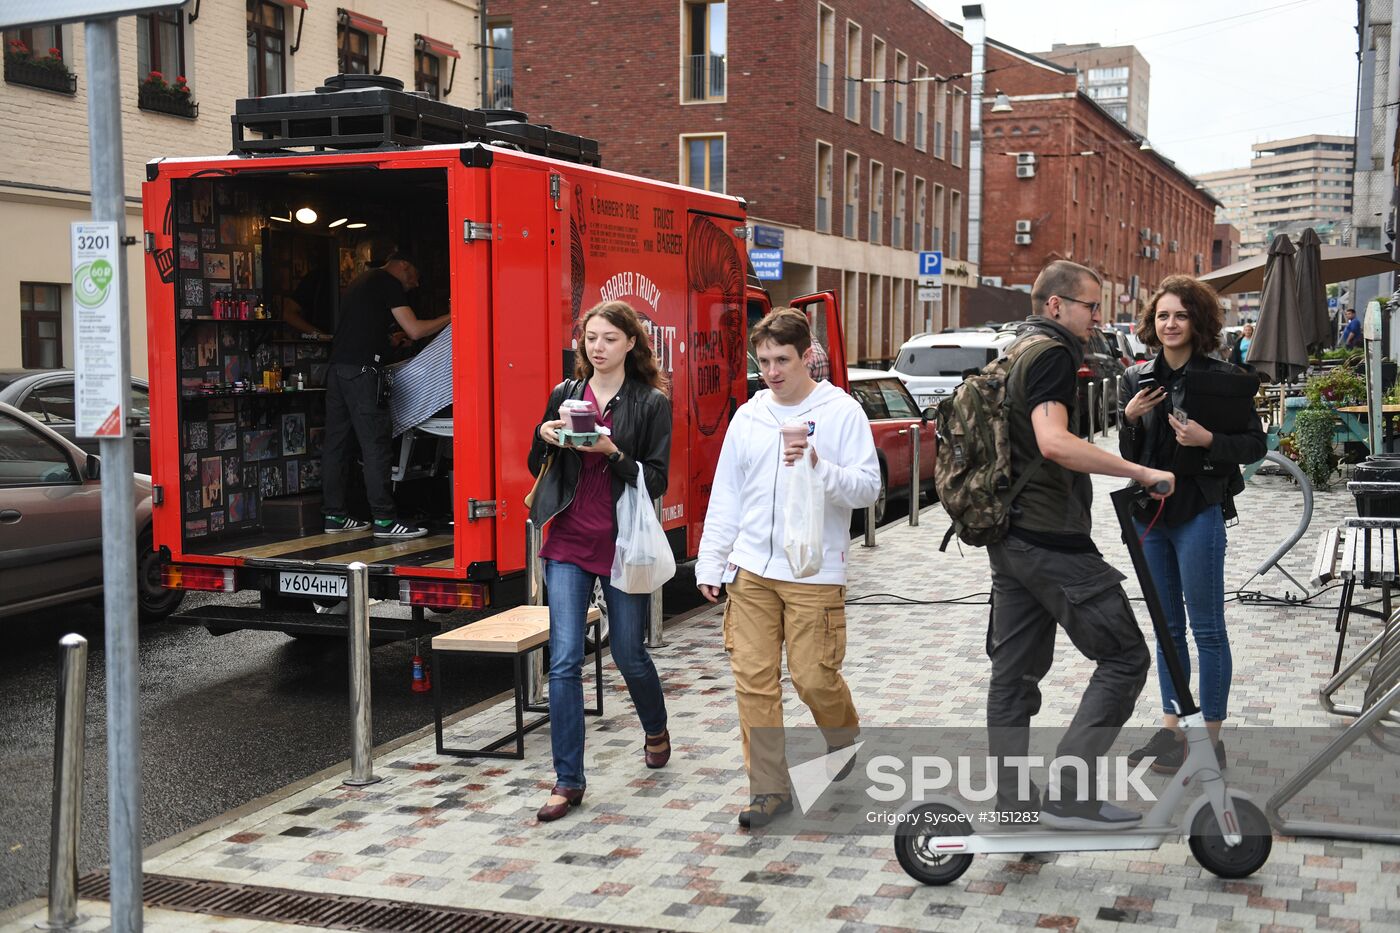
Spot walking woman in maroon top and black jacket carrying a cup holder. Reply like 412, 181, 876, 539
529, 301, 671, 822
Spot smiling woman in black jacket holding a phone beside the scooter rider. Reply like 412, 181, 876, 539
1119, 275, 1267, 773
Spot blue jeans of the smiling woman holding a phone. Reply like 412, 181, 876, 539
1133, 506, 1231, 723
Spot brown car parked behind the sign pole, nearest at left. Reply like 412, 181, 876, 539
0, 403, 185, 619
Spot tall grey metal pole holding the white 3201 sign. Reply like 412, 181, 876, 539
78, 18, 143, 933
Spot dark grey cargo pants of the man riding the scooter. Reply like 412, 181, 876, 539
987, 538, 1151, 810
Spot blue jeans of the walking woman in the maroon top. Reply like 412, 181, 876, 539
545, 560, 666, 789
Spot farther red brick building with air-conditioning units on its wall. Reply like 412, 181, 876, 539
981, 39, 1217, 319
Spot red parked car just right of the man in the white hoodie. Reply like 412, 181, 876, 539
848, 368, 935, 523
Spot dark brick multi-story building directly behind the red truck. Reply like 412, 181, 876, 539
487, 0, 977, 361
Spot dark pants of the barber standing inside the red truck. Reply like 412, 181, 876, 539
321, 363, 399, 518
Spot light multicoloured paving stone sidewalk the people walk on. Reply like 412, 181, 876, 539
10, 441, 1400, 932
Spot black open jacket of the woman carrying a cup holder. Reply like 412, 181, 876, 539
529, 378, 671, 528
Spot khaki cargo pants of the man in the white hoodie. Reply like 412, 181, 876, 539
724, 570, 860, 794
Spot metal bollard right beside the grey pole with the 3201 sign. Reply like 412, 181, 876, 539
41, 635, 87, 930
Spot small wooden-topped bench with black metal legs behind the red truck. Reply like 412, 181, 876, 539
433, 605, 603, 759
